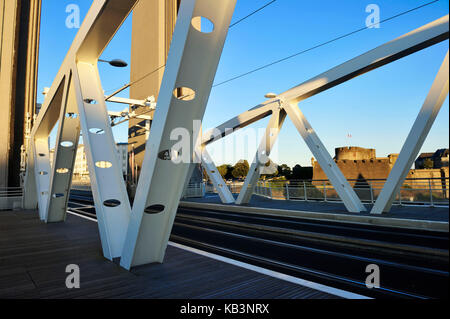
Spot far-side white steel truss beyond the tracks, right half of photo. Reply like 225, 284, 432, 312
203, 15, 449, 213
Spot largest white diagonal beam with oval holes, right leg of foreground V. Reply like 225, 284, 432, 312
120, 0, 236, 269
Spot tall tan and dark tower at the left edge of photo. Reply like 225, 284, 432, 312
0, 0, 41, 188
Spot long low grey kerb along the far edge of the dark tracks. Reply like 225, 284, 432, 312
180, 201, 449, 232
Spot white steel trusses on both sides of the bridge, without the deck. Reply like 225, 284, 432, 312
24, 0, 449, 269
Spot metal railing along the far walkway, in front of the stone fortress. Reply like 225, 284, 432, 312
251, 177, 449, 206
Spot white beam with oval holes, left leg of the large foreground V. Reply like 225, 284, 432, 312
73, 62, 131, 260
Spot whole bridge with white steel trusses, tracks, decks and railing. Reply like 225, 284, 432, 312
0, 0, 449, 299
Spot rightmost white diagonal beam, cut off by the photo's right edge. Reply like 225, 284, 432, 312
370, 51, 449, 214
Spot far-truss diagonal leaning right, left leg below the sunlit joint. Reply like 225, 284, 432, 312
236, 109, 286, 205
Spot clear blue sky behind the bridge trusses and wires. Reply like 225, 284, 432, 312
38, 0, 449, 166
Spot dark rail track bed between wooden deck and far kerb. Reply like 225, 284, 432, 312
70, 192, 448, 298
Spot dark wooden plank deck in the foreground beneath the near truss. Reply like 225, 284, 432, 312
0, 211, 336, 299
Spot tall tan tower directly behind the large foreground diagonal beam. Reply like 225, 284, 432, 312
128, 0, 181, 180
